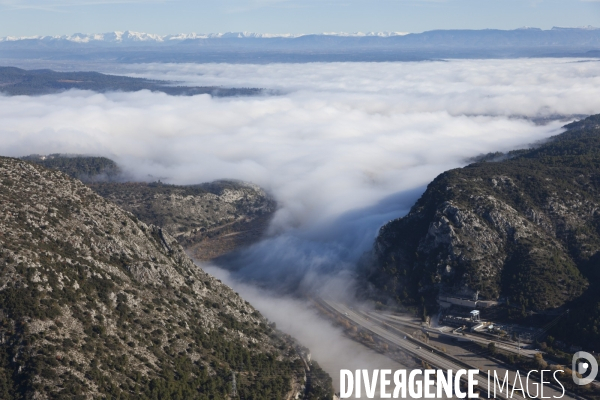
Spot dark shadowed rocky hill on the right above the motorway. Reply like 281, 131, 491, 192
366, 116, 600, 310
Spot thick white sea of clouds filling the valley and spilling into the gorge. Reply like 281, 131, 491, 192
0, 59, 600, 284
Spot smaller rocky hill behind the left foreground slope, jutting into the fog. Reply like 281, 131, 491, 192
90, 181, 276, 260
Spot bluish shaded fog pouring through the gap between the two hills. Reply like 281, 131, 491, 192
215, 186, 425, 290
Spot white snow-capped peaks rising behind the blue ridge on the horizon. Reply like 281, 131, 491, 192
0, 31, 408, 43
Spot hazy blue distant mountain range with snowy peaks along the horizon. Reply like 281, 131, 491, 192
0, 26, 600, 63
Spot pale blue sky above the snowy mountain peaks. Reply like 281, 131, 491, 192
0, 0, 600, 36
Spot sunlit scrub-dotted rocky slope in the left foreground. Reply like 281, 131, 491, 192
0, 158, 329, 399
